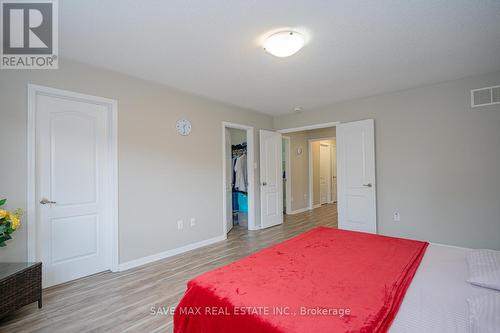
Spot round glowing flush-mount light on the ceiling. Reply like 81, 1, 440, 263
263, 31, 305, 58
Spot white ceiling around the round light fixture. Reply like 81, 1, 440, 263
59, 0, 500, 115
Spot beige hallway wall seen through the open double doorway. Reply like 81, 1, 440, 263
285, 127, 336, 211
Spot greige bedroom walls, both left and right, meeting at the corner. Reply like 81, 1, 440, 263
0, 60, 500, 263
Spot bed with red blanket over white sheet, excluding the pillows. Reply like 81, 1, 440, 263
174, 227, 491, 333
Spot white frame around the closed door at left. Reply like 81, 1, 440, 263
26, 84, 119, 272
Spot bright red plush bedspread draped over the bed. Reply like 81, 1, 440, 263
174, 227, 428, 333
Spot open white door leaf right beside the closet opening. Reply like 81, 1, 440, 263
260, 130, 283, 228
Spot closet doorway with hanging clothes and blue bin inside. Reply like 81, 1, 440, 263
222, 122, 256, 235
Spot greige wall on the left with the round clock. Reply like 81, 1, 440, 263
0, 60, 272, 263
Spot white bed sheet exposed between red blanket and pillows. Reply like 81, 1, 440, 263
389, 244, 500, 333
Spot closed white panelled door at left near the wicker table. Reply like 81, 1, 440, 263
35, 95, 111, 287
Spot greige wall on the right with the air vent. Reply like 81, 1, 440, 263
274, 72, 500, 250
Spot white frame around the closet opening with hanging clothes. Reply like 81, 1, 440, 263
222, 121, 259, 231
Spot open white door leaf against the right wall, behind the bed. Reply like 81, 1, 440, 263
337, 119, 377, 233
